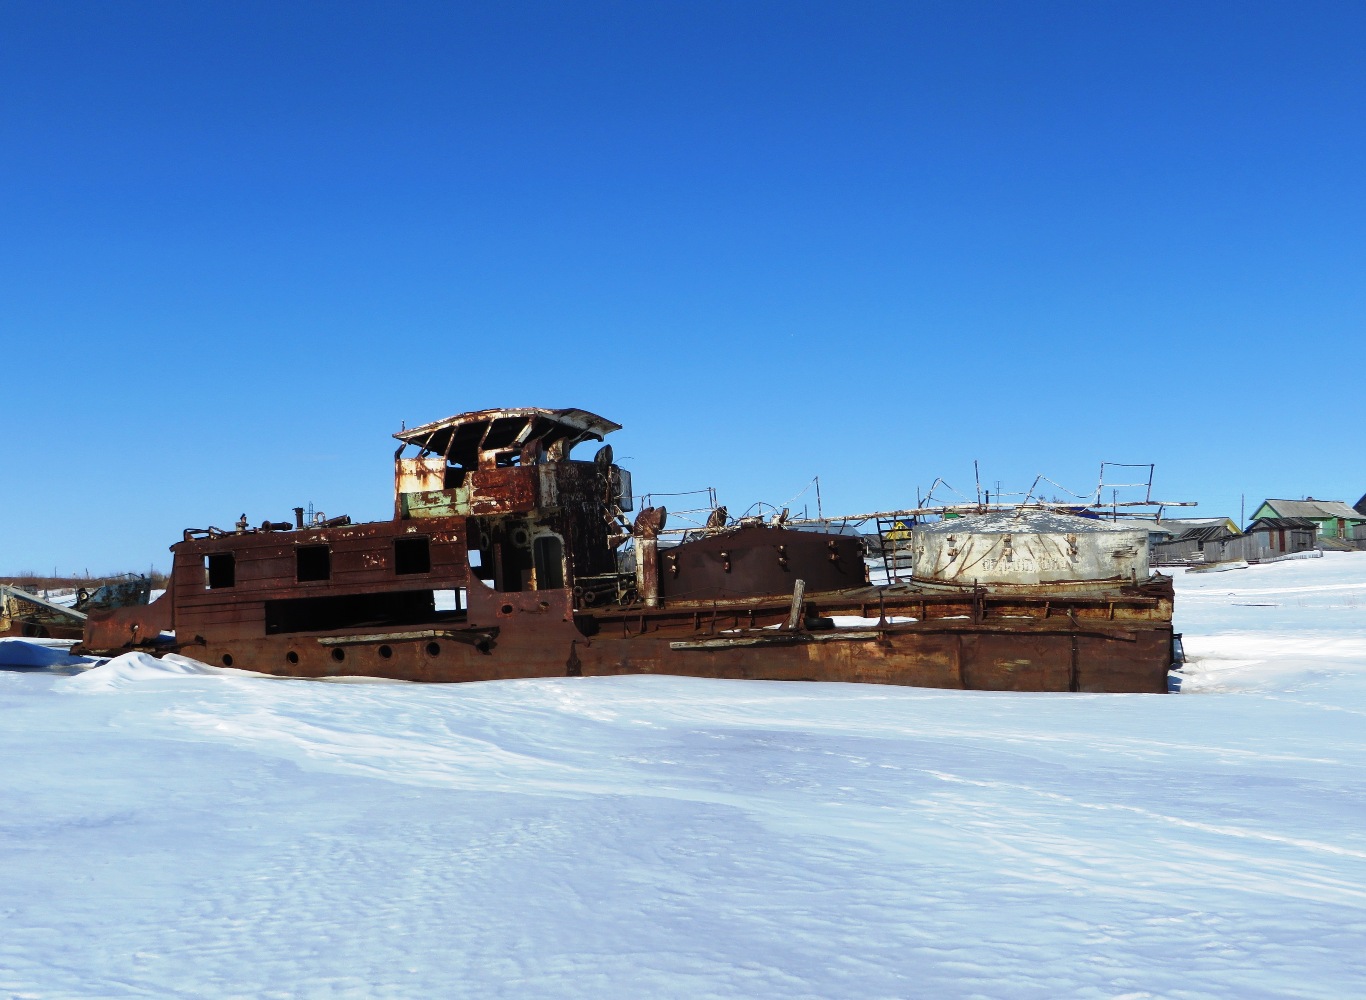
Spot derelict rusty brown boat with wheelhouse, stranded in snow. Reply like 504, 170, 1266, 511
83, 408, 1172, 693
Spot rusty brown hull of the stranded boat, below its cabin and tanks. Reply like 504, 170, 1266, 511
87, 579, 1172, 694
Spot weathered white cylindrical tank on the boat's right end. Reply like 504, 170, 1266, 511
912, 511, 1147, 586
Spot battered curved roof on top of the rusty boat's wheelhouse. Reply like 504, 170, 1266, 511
395, 407, 622, 466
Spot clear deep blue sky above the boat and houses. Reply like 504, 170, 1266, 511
0, 0, 1366, 572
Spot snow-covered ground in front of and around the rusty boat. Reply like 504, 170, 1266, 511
0, 553, 1366, 999
